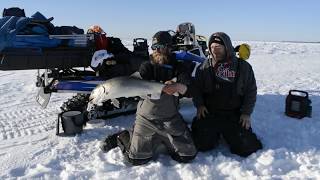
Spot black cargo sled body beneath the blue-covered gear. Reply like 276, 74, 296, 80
0, 34, 94, 71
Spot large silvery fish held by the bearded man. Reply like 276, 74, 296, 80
88, 74, 171, 109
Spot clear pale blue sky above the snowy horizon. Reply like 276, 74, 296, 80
0, 0, 320, 41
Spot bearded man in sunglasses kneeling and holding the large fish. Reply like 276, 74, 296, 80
101, 31, 197, 165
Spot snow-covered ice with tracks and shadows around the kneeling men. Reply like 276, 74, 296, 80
0, 41, 320, 180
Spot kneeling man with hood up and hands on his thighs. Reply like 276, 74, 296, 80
192, 32, 262, 156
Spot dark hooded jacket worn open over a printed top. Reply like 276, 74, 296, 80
188, 33, 257, 115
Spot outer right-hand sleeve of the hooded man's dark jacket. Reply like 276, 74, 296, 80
241, 65, 257, 115
